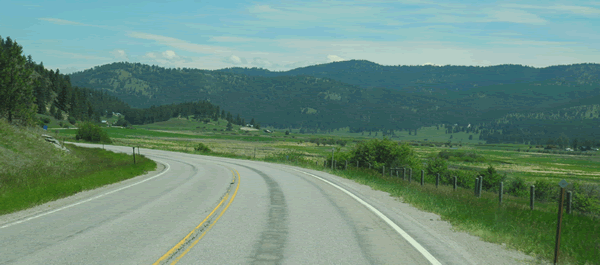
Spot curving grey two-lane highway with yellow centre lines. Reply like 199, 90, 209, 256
0, 144, 494, 264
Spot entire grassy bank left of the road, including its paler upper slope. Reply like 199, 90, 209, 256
0, 121, 156, 214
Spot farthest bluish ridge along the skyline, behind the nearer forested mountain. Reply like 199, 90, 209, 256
216, 60, 600, 93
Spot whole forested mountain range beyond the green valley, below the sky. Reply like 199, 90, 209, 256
70, 61, 600, 142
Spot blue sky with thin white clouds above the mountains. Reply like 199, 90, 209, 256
0, 0, 600, 73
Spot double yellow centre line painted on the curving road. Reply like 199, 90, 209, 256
153, 169, 240, 265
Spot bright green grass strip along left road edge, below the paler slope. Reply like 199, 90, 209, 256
0, 145, 156, 215
